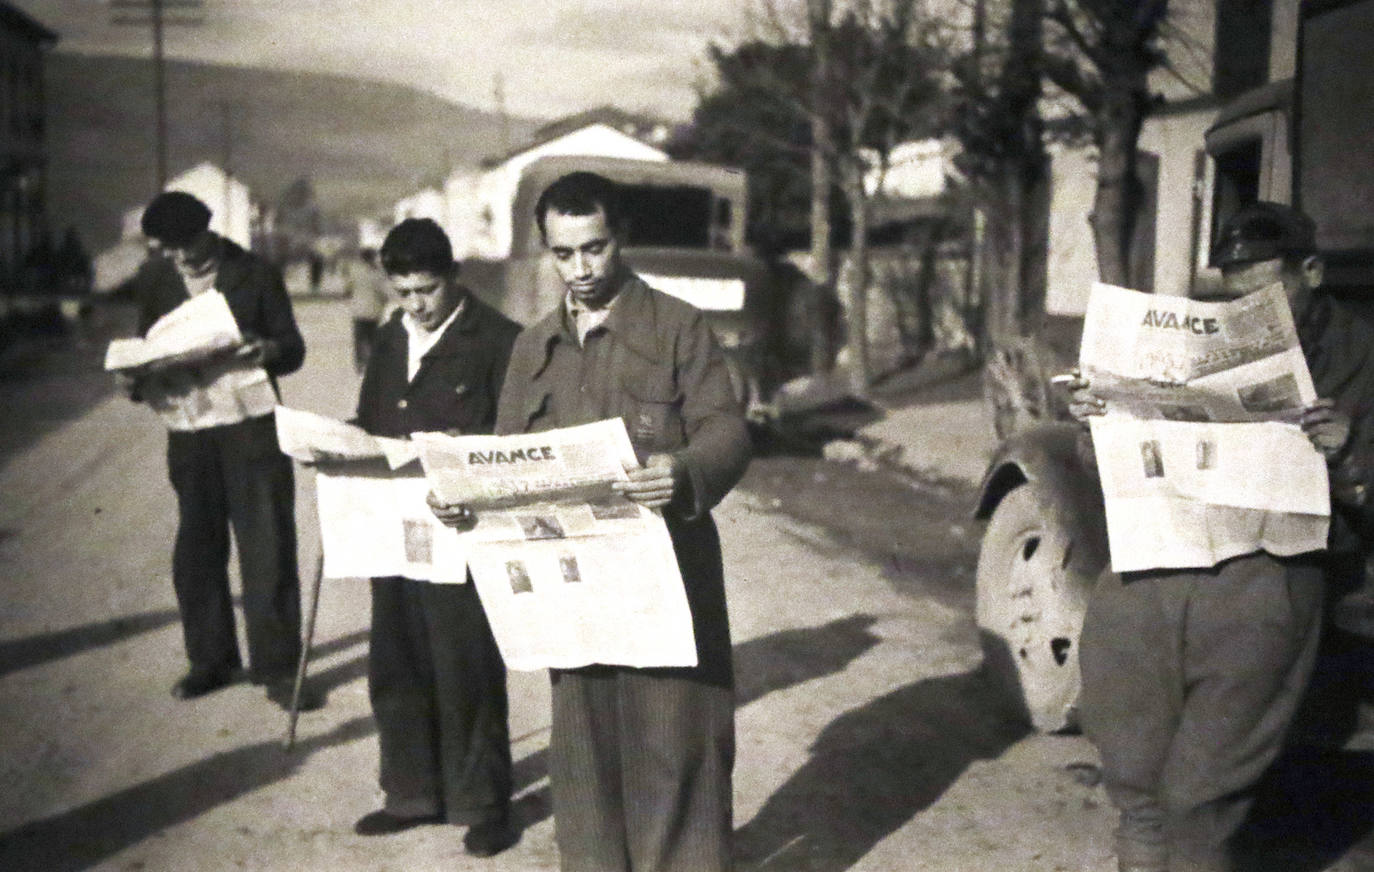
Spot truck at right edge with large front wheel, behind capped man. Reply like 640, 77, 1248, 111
976, 0, 1374, 732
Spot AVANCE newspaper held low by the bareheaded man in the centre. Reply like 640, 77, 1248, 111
412, 419, 697, 670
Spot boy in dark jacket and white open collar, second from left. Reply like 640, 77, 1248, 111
353, 218, 519, 857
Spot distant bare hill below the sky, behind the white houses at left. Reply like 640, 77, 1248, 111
47, 52, 540, 250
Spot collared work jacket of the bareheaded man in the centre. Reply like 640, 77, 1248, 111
496, 275, 750, 685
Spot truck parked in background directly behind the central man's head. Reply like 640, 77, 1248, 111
462, 155, 779, 419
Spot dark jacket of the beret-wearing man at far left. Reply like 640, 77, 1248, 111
135, 236, 305, 379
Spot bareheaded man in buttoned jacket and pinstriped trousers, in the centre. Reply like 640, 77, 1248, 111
436, 173, 750, 872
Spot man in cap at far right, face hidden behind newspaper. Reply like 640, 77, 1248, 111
1070, 202, 1374, 872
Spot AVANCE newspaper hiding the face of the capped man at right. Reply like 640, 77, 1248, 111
1079, 284, 1330, 573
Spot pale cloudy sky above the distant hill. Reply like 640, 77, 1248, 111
10, 0, 753, 121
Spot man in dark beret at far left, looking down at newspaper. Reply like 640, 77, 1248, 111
121, 191, 320, 709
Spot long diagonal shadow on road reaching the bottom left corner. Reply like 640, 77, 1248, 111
0, 717, 372, 872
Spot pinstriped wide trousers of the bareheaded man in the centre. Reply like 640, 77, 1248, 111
550, 664, 735, 872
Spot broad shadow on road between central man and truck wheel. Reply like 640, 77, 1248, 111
735, 672, 1025, 872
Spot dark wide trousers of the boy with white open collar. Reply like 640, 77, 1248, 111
367, 578, 513, 824
